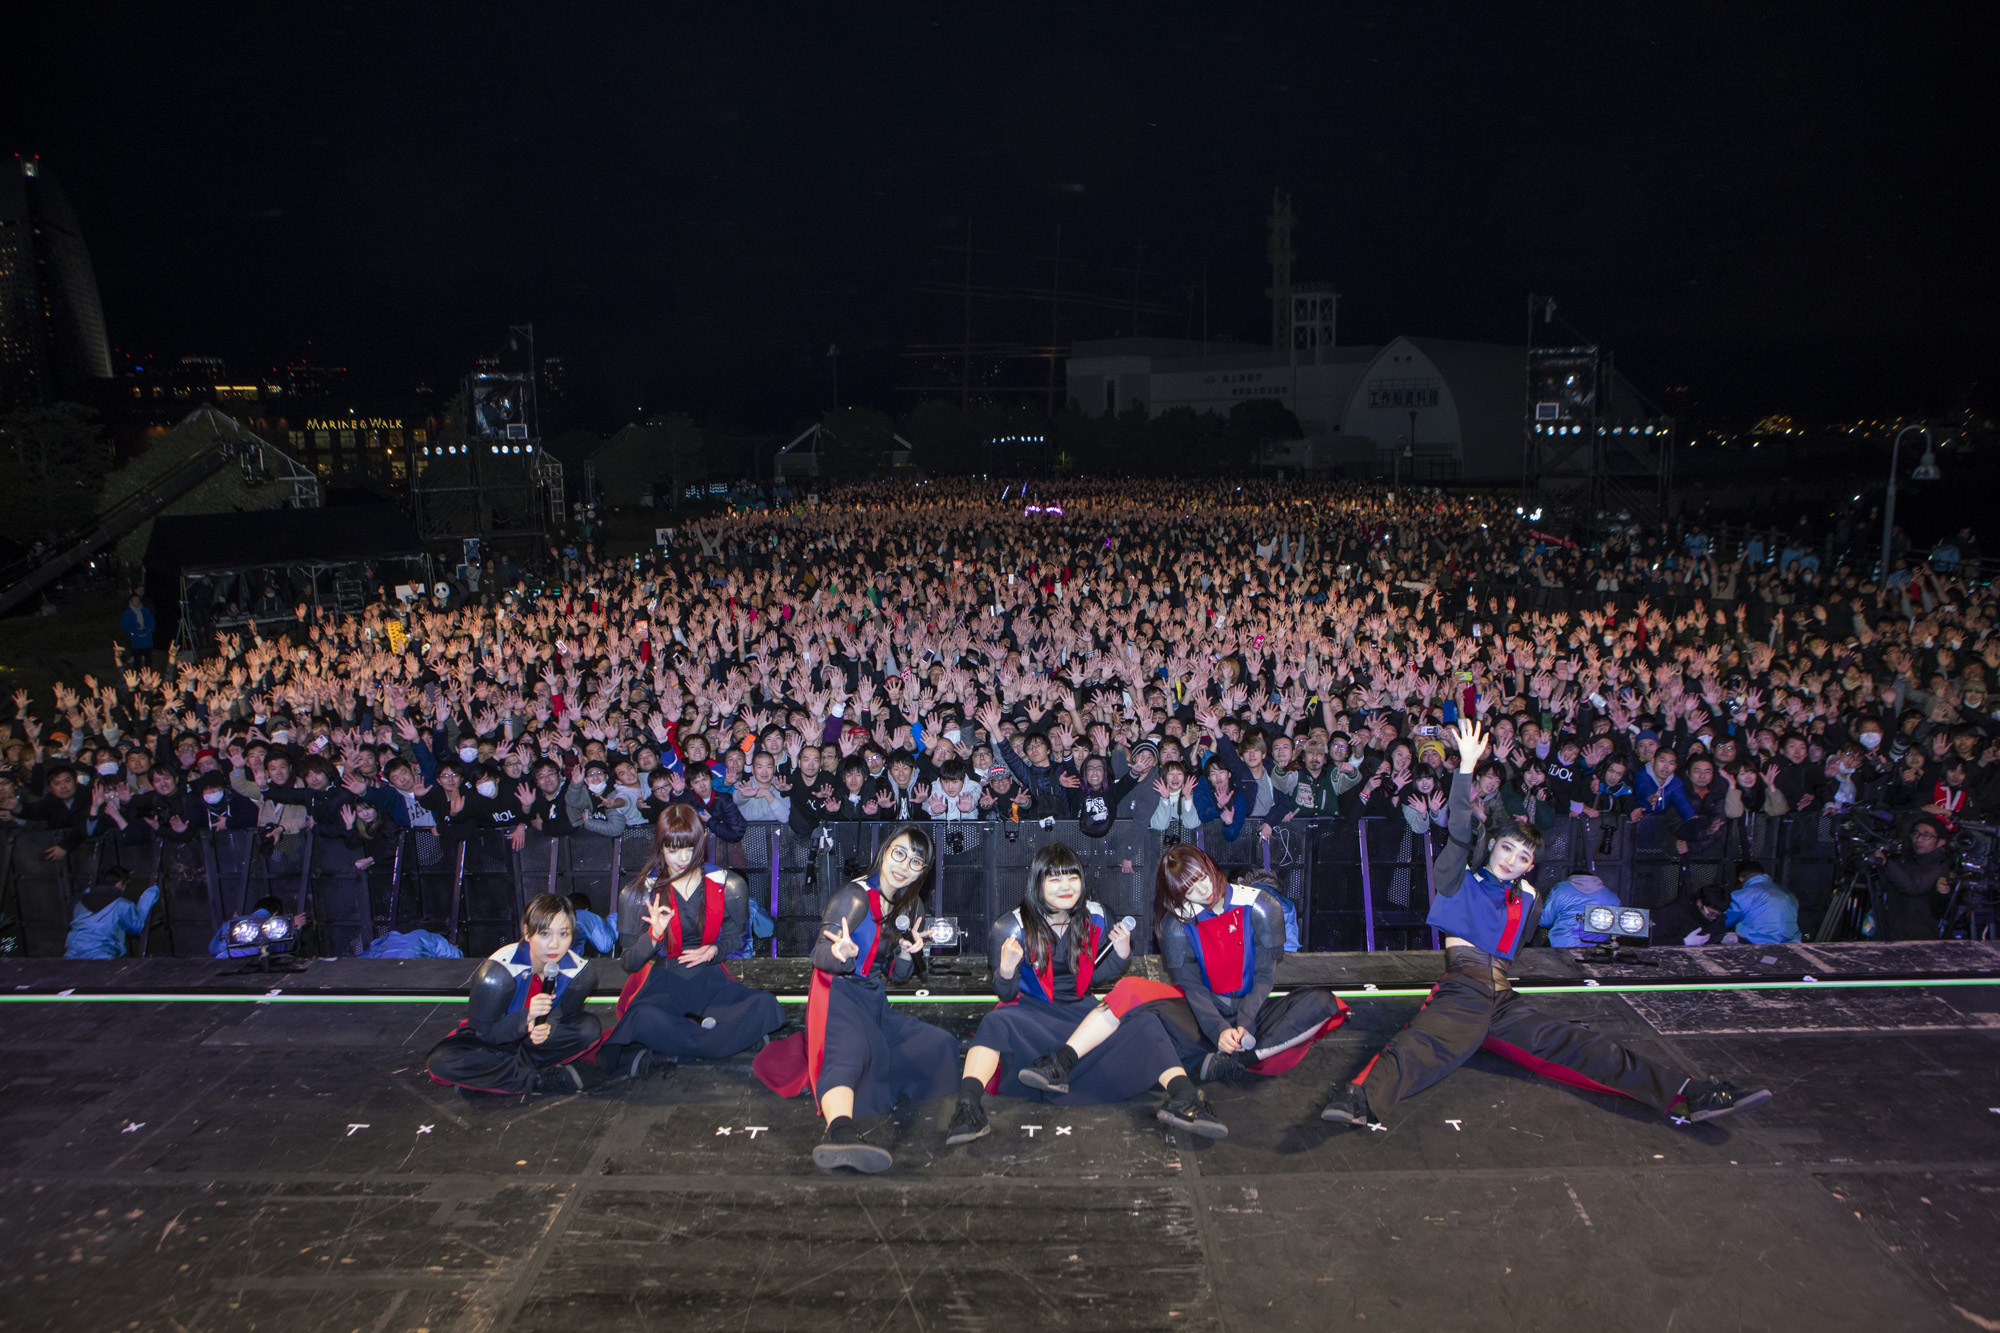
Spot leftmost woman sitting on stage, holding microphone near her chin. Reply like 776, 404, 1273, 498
424, 893, 598, 1095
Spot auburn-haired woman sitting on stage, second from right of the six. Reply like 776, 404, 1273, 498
1020, 843, 1348, 1112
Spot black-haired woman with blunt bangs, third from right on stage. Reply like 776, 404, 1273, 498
946, 843, 1200, 1145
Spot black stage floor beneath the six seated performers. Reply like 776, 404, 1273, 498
0, 945, 2000, 1333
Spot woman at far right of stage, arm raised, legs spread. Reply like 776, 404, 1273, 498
1320, 719, 1770, 1125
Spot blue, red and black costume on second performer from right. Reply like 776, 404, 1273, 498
1104, 885, 1348, 1075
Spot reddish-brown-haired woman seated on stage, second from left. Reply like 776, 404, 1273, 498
596, 805, 784, 1079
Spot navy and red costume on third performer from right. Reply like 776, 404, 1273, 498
972, 903, 1180, 1107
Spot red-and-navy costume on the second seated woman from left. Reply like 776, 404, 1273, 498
596, 865, 784, 1069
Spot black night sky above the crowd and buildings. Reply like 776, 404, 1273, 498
0, 2, 2000, 430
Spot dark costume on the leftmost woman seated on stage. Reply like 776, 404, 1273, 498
424, 941, 600, 1093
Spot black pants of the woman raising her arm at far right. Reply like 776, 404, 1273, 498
1354, 949, 1688, 1119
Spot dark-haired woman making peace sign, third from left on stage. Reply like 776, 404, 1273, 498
756, 827, 958, 1173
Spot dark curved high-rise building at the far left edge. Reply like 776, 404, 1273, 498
0, 156, 112, 406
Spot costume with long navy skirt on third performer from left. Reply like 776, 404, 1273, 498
752, 875, 958, 1117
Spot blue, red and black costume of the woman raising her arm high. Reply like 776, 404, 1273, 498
1354, 773, 1688, 1119
